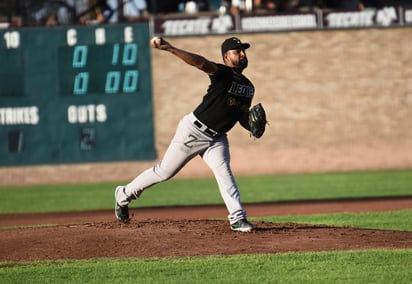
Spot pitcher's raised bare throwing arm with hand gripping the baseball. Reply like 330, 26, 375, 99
150, 37, 217, 74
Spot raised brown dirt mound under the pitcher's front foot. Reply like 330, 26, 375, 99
0, 220, 412, 261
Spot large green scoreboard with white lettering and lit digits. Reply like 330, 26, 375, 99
0, 23, 156, 166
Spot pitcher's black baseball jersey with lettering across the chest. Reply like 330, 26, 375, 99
193, 64, 255, 134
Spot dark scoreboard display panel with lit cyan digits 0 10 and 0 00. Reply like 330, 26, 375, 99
58, 43, 139, 95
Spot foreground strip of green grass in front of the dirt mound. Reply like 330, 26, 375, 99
0, 250, 412, 284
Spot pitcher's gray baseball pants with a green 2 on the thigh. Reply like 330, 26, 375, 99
116, 113, 246, 224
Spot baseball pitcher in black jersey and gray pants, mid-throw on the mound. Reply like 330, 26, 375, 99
115, 37, 266, 232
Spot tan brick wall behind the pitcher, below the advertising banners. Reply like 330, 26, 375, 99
153, 29, 412, 148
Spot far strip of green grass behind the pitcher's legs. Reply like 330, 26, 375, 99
0, 170, 412, 213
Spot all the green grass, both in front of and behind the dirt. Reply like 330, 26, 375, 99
0, 170, 412, 284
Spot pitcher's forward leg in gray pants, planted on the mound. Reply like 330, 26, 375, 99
202, 136, 246, 224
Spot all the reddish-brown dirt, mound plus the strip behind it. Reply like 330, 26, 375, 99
0, 197, 412, 261
